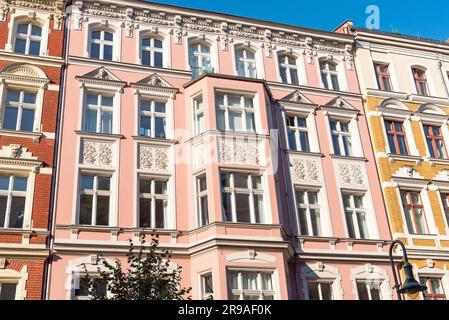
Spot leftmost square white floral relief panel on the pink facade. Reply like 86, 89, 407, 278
80, 139, 114, 167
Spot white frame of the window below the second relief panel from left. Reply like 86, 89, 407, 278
137, 174, 170, 229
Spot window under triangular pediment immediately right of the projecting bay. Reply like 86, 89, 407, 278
287, 115, 310, 152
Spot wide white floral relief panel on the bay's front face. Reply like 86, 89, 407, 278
218, 138, 260, 165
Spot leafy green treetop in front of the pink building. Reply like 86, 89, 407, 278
80, 234, 191, 300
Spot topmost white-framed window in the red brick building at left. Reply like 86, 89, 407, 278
14, 22, 42, 56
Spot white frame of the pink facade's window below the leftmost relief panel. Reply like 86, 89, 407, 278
76, 170, 114, 227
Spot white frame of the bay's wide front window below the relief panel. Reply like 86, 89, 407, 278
219, 170, 268, 224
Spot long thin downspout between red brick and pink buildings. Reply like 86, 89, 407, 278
42, 1, 71, 300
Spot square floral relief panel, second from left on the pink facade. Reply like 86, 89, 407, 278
139, 144, 169, 172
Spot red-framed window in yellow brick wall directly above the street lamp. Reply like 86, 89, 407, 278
401, 191, 428, 234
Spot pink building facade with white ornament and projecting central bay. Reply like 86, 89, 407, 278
47, 0, 393, 299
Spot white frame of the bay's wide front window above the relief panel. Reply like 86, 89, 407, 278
214, 91, 260, 134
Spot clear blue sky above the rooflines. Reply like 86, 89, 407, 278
150, 0, 449, 40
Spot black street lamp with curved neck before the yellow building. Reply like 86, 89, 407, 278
389, 240, 427, 300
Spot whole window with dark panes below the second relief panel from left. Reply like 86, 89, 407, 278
139, 177, 168, 229
